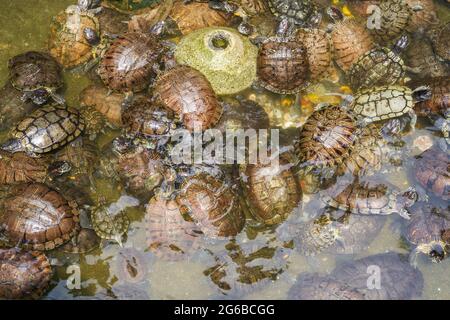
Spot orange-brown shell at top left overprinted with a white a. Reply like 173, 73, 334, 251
49, 5, 100, 68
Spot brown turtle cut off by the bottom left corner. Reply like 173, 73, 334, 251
0, 248, 53, 300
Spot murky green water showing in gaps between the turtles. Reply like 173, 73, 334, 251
0, 0, 450, 299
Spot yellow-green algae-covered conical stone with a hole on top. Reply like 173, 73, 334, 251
175, 27, 258, 95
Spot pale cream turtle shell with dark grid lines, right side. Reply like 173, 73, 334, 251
350, 85, 414, 122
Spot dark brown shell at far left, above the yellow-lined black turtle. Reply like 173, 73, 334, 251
8, 51, 64, 91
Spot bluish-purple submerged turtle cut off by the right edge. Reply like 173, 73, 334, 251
413, 147, 450, 201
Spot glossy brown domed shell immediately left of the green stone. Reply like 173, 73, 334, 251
98, 32, 162, 92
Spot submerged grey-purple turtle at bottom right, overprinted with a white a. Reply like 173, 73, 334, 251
331, 252, 424, 300
